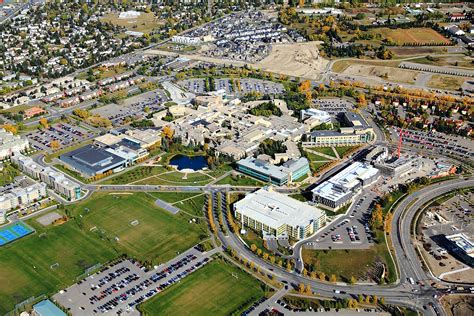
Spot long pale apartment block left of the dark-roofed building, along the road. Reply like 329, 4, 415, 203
12, 154, 82, 201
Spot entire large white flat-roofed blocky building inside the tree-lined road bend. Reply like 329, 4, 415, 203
234, 187, 326, 240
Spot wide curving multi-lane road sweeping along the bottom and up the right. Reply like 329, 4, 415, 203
208, 178, 474, 315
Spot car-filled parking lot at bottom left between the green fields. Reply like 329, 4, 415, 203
53, 248, 216, 315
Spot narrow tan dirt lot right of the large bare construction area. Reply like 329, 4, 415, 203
342, 64, 419, 83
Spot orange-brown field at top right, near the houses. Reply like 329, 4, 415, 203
369, 27, 450, 45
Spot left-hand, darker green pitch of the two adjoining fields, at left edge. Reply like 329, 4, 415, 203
0, 219, 119, 315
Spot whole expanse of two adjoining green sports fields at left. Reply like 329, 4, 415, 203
0, 193, 207, 315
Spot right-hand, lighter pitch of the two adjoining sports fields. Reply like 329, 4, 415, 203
73, 193, 207, 263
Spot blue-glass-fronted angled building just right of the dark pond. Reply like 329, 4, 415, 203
237, 157, 310, 185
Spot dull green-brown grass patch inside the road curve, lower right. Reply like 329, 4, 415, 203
303, 233, 396, 281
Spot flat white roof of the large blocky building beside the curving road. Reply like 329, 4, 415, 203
235, 187, 324, 227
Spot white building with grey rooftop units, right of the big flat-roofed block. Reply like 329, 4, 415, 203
311, 162, 379, 211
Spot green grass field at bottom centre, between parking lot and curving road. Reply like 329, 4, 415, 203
140, 259, 265, 316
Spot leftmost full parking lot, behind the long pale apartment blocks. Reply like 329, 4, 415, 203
27, 123, 97, 150
